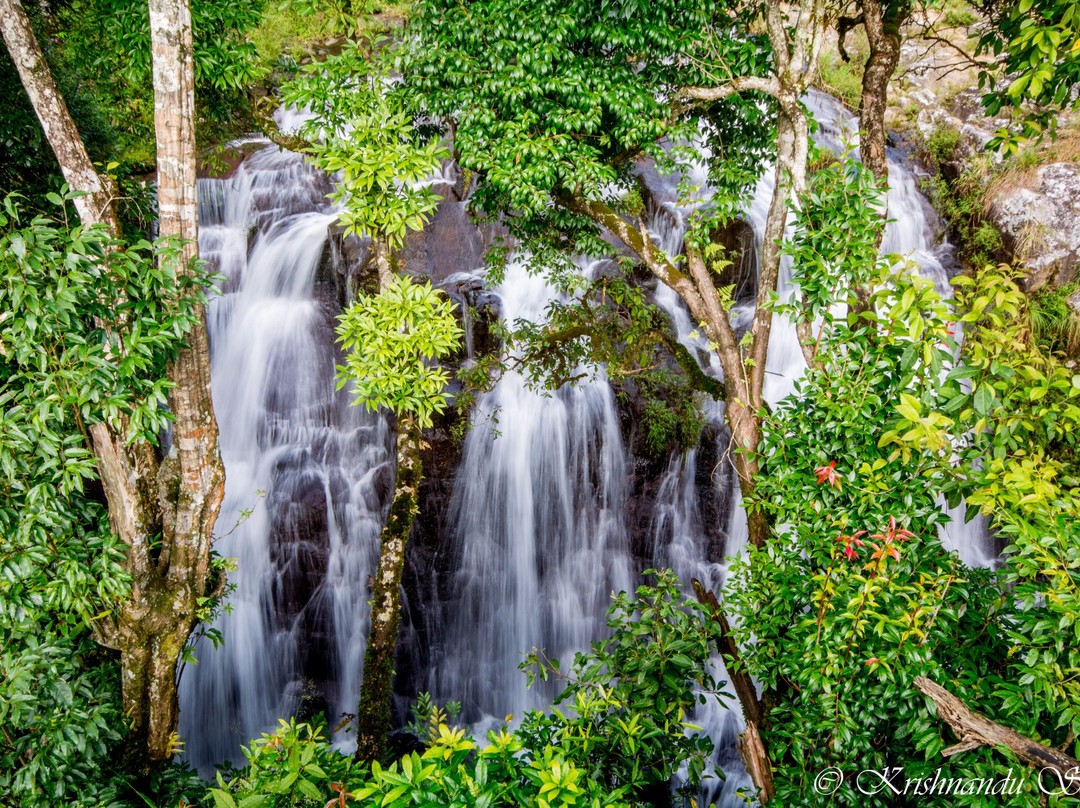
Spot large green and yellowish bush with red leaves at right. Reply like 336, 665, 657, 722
726, 164, 1080, 806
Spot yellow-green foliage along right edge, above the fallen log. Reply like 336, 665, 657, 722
941, 267, 1080, 755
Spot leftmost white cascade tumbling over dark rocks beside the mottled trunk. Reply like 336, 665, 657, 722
180, 147, 393, 772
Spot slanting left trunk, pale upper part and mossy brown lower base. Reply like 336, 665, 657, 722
0, 0, 212, 760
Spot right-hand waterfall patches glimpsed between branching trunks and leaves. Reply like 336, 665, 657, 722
649, 93, 990, 805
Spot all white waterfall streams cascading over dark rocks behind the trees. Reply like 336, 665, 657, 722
174, 95, 991, 806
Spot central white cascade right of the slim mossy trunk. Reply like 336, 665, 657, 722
431, 262, 634, 723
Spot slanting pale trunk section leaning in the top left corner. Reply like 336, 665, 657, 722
0, 0, 120, 237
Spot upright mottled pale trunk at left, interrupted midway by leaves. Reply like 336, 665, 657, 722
114, 0, 225, 760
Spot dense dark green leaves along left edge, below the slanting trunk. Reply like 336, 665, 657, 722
0, 194, 217, 808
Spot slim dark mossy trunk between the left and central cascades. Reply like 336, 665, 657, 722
356, 416, 422, 762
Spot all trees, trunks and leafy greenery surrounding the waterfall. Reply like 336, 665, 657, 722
0, 0, 1080, 808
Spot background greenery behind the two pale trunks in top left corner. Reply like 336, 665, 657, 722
0, 0, 274, 205
